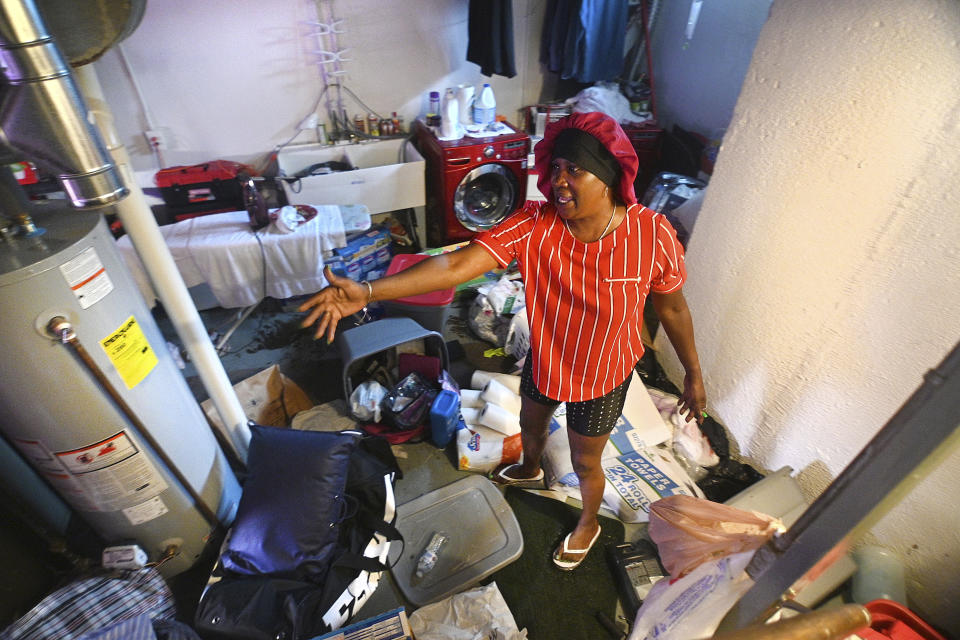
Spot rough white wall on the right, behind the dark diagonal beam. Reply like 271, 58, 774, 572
657, 0, 960, 632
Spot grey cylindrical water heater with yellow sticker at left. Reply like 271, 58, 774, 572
0, 201, 240, 576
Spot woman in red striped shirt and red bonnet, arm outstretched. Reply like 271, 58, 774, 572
300, 113, 706, 570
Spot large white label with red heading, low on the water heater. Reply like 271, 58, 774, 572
55, 431, 168, 517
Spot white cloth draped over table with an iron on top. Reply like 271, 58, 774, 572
117, 205, 370, 309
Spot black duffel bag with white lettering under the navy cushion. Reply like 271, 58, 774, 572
194, 437, 402, 640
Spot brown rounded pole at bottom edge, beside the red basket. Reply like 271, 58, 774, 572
711, 604, 870, 640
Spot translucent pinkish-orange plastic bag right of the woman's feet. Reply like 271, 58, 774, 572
648, 495, 785, 578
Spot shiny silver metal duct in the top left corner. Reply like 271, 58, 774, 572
0, 0, 127, 208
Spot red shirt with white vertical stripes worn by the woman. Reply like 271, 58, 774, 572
473, 202, 686, 402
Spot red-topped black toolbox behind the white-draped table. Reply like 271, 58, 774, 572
154, 160, 258, 215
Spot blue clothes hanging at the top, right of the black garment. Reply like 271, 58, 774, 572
540, 0, 629, 83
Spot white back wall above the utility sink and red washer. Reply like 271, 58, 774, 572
96, 0, 545, 176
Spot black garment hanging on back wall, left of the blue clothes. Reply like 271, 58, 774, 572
467, 0, 517, 78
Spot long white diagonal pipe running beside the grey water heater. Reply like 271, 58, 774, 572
76, 65, 250, 463
